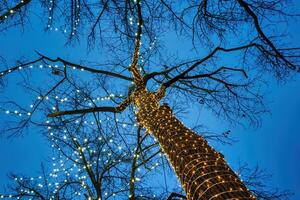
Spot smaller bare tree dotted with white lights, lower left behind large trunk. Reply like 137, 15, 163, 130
0, 115, 168, 200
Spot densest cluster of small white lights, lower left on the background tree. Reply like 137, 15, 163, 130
0, 131, 141, 200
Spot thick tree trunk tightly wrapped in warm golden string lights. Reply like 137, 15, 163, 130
135, 91, 256, 200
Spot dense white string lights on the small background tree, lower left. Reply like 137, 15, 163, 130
0, 114, 141, 200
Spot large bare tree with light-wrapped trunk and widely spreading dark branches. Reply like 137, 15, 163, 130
0, 0, 299, 199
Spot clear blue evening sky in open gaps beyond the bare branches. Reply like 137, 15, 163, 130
0, 1, 300, 200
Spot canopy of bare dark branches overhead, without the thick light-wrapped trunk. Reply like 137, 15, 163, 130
0, 0, 300, 199
